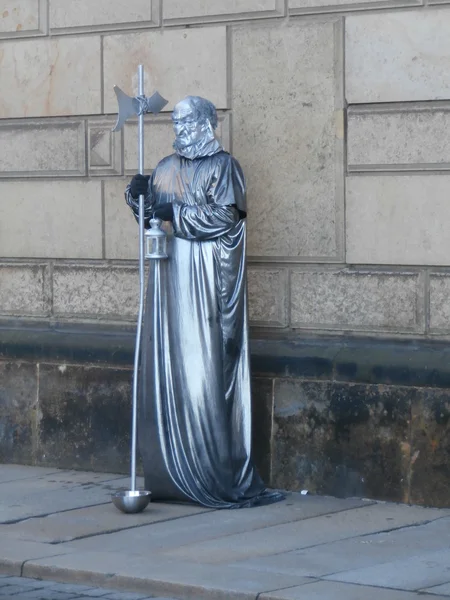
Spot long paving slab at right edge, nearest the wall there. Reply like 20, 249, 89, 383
160, 504, 450, 564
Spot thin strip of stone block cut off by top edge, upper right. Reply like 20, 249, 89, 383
289, 0, 421, 15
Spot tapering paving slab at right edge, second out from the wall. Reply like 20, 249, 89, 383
230, 517, 450, 580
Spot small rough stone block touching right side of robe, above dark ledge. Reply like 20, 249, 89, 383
247, 266, 288, 327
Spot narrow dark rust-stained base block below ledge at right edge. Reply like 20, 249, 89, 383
410, 389, 450, 507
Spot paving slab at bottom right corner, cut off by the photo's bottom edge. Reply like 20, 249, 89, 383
258, 581, 448, 600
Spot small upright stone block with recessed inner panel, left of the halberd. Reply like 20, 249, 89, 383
88, 118, 123, 176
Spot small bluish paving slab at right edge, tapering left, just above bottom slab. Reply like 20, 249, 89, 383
325, 548, 450, 590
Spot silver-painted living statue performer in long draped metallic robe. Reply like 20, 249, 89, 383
125, 96, 283, 508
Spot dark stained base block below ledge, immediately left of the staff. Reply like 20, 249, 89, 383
38, 365, 131, 473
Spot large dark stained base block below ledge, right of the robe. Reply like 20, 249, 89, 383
272, 379, 411, 501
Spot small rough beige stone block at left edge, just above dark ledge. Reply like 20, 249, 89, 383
0, 263, 50, 317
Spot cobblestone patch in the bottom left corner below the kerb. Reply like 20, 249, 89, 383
0, 575, 180, 600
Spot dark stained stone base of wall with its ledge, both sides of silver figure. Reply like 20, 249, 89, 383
0, 326, 450, 507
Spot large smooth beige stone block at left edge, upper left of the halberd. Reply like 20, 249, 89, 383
0, 36, 101, 119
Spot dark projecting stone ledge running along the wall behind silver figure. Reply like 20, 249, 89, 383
0, 322, 450, 388
